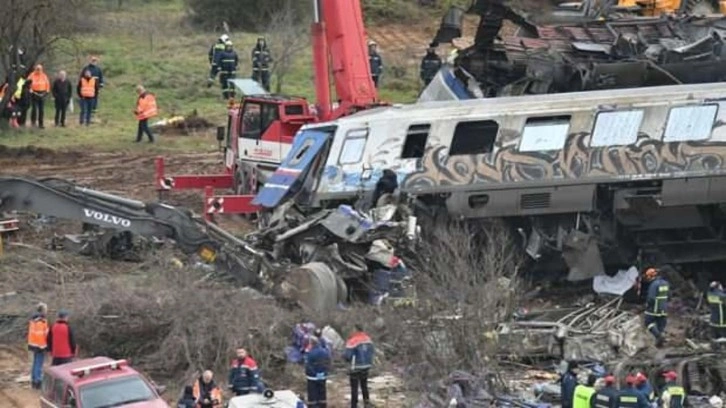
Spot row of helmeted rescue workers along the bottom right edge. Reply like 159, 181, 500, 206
560, 362, 686, 408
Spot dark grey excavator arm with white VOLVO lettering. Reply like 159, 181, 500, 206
0, 177, 264, 284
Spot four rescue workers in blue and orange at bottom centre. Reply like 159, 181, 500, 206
177, 325, 375, 408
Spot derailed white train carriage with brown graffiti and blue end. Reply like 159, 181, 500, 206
256, 83, 726, 280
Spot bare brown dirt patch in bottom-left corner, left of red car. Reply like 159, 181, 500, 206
0, 345, 38, 408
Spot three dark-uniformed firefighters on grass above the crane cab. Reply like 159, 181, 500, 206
207, 34, 272, 100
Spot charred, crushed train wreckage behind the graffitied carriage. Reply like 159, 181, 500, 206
421, 0, 726, 101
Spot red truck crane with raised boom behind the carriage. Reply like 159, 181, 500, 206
156, 0, 386, 218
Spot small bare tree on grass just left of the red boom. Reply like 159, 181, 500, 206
267, 3, 310, 93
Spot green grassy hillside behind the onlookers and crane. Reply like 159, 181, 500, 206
0, 0, 426, 151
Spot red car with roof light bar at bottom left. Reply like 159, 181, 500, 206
40, 357, 169, 408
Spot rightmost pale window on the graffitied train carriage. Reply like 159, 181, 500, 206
663, 105, 718, 142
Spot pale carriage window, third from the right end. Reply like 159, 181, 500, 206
519, 115, 570, 152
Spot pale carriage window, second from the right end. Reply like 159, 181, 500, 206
590, 109, 643, 147
